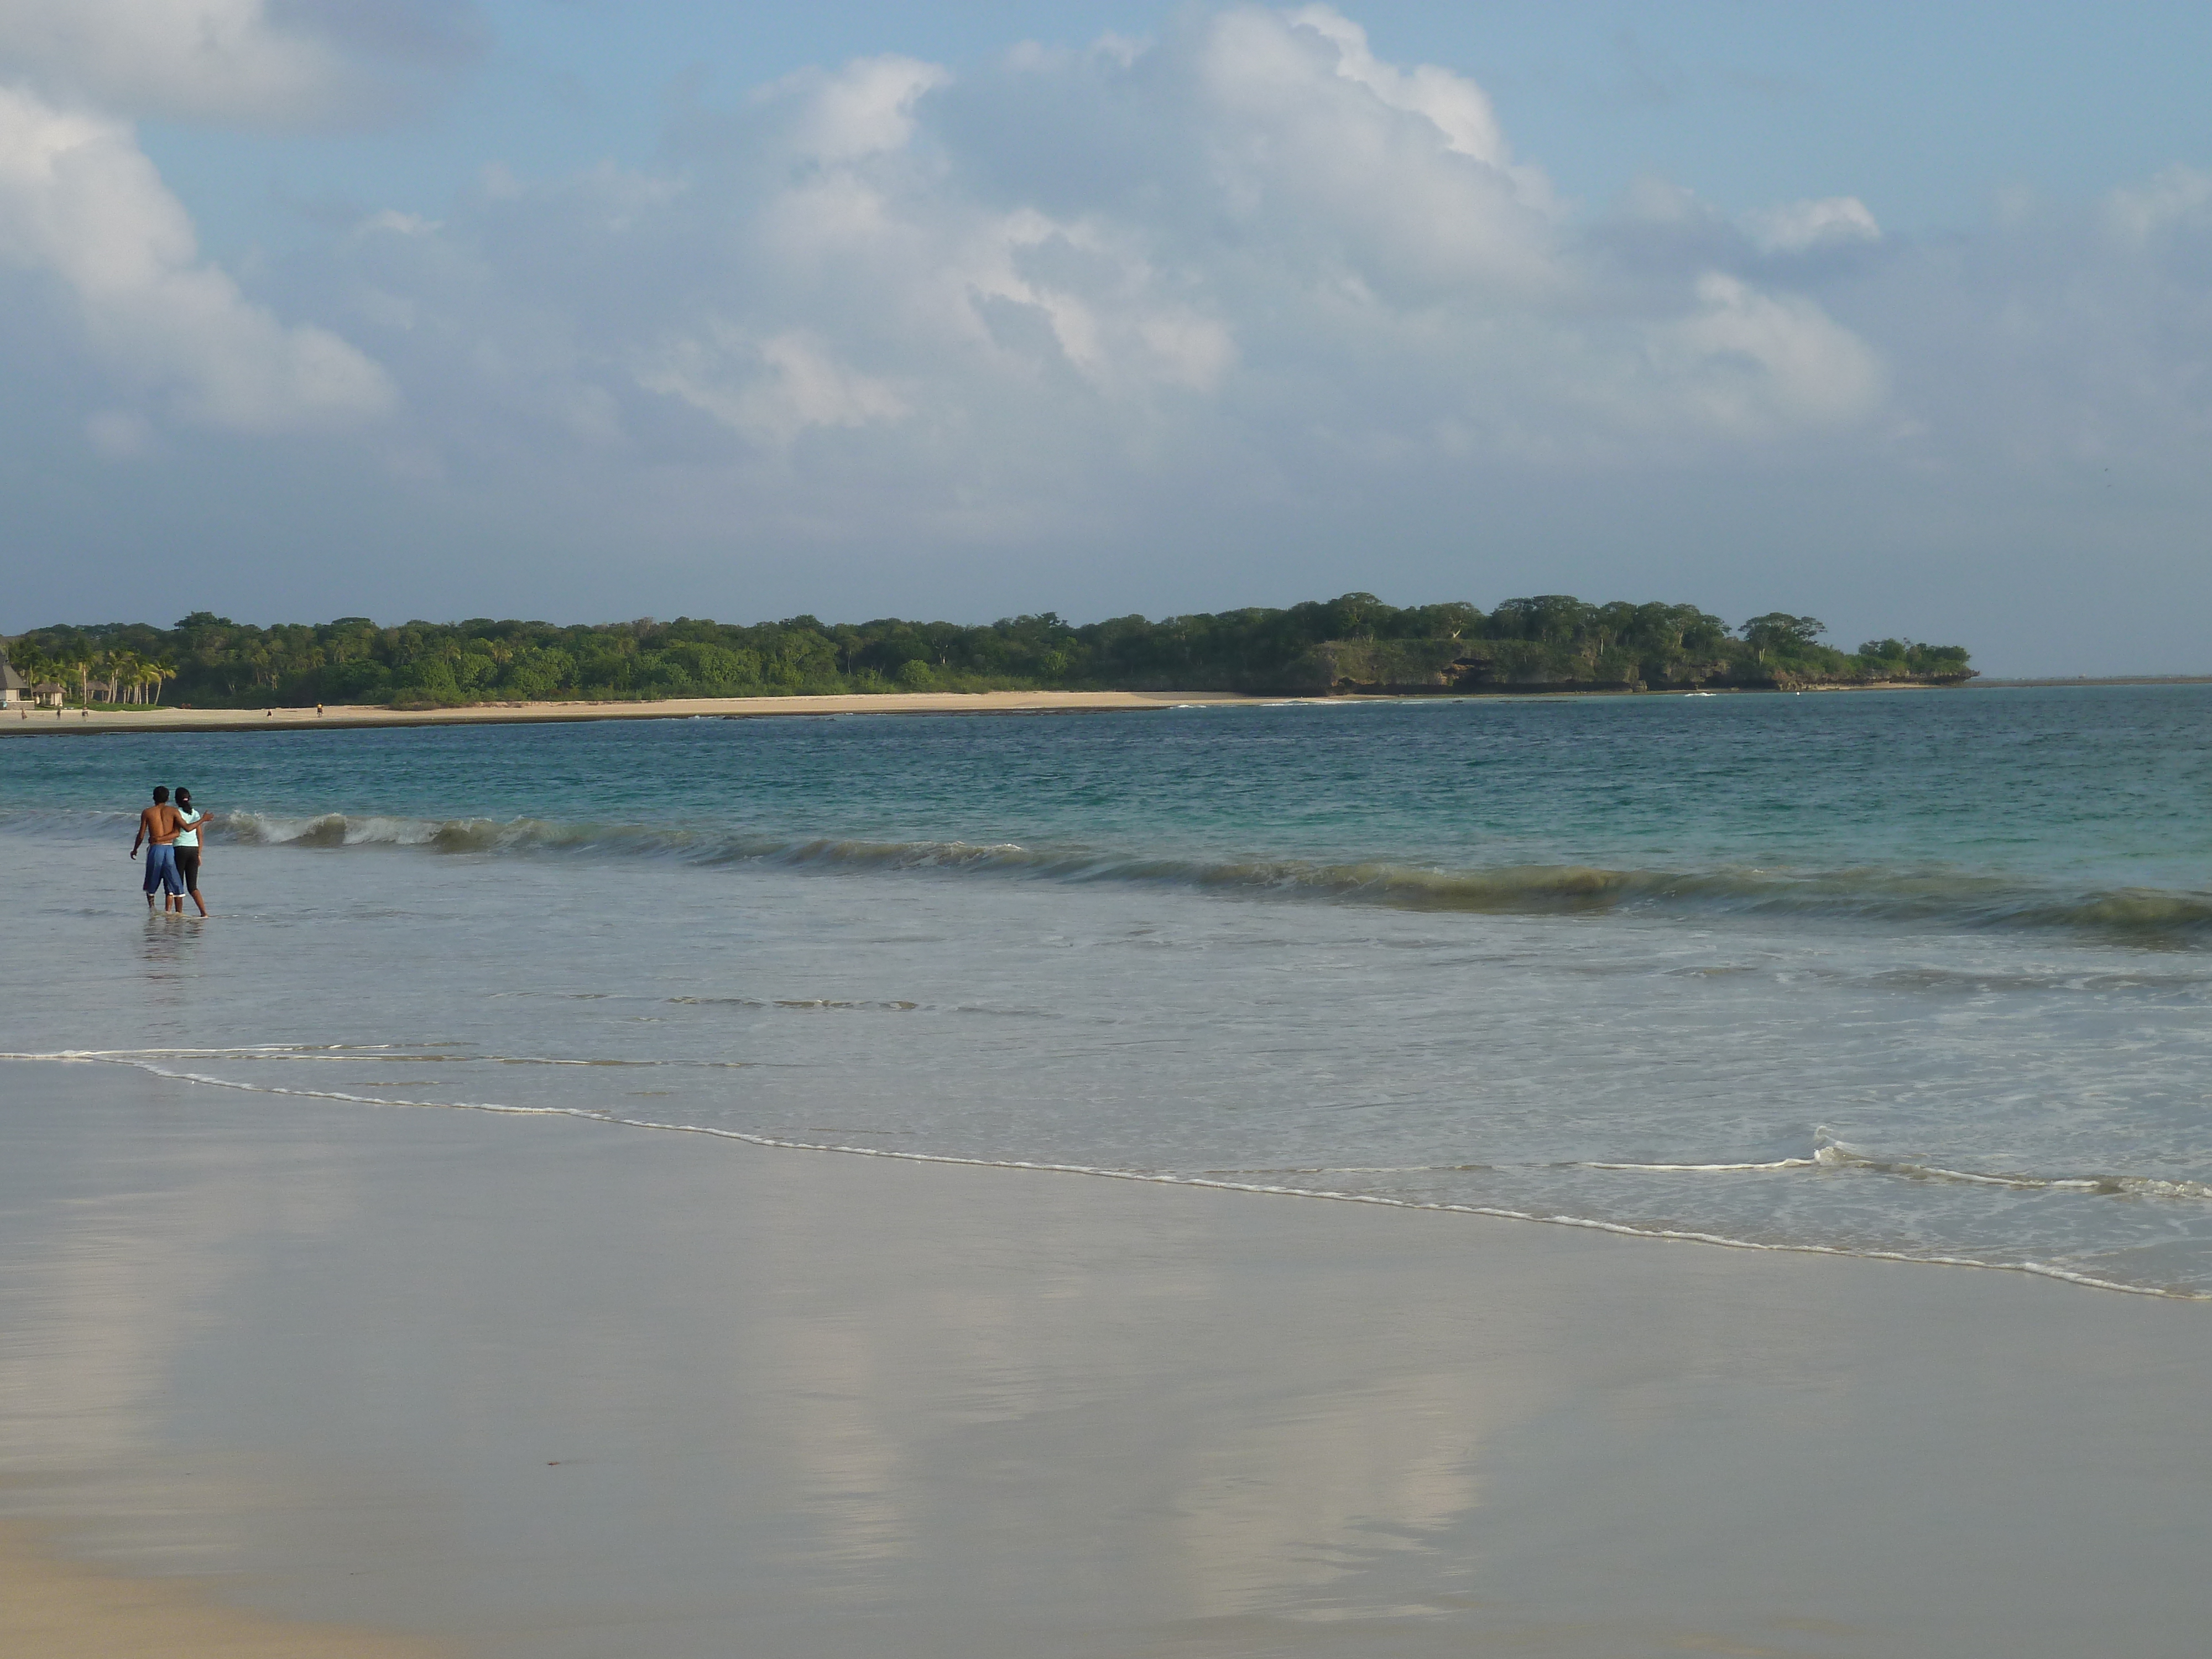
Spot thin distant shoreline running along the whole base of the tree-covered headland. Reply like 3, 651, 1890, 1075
0, 677, 2008, 737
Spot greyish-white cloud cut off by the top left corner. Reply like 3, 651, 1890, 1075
0, 0, 478, 126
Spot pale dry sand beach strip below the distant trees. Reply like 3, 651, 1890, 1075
0, 692, 1252, 737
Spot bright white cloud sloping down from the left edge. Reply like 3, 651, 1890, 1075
0, 88, 394, 429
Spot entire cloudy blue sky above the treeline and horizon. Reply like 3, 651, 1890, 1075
0, 0, 2212, 675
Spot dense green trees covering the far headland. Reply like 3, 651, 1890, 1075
7, 593, 1973, 708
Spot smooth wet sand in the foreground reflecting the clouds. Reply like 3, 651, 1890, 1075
13, 1062, 2212, 1659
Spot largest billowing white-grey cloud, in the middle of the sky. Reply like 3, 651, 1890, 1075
330, 7, 1885, 500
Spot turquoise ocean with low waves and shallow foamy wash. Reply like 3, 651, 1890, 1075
0, 686, 2212, 1296
